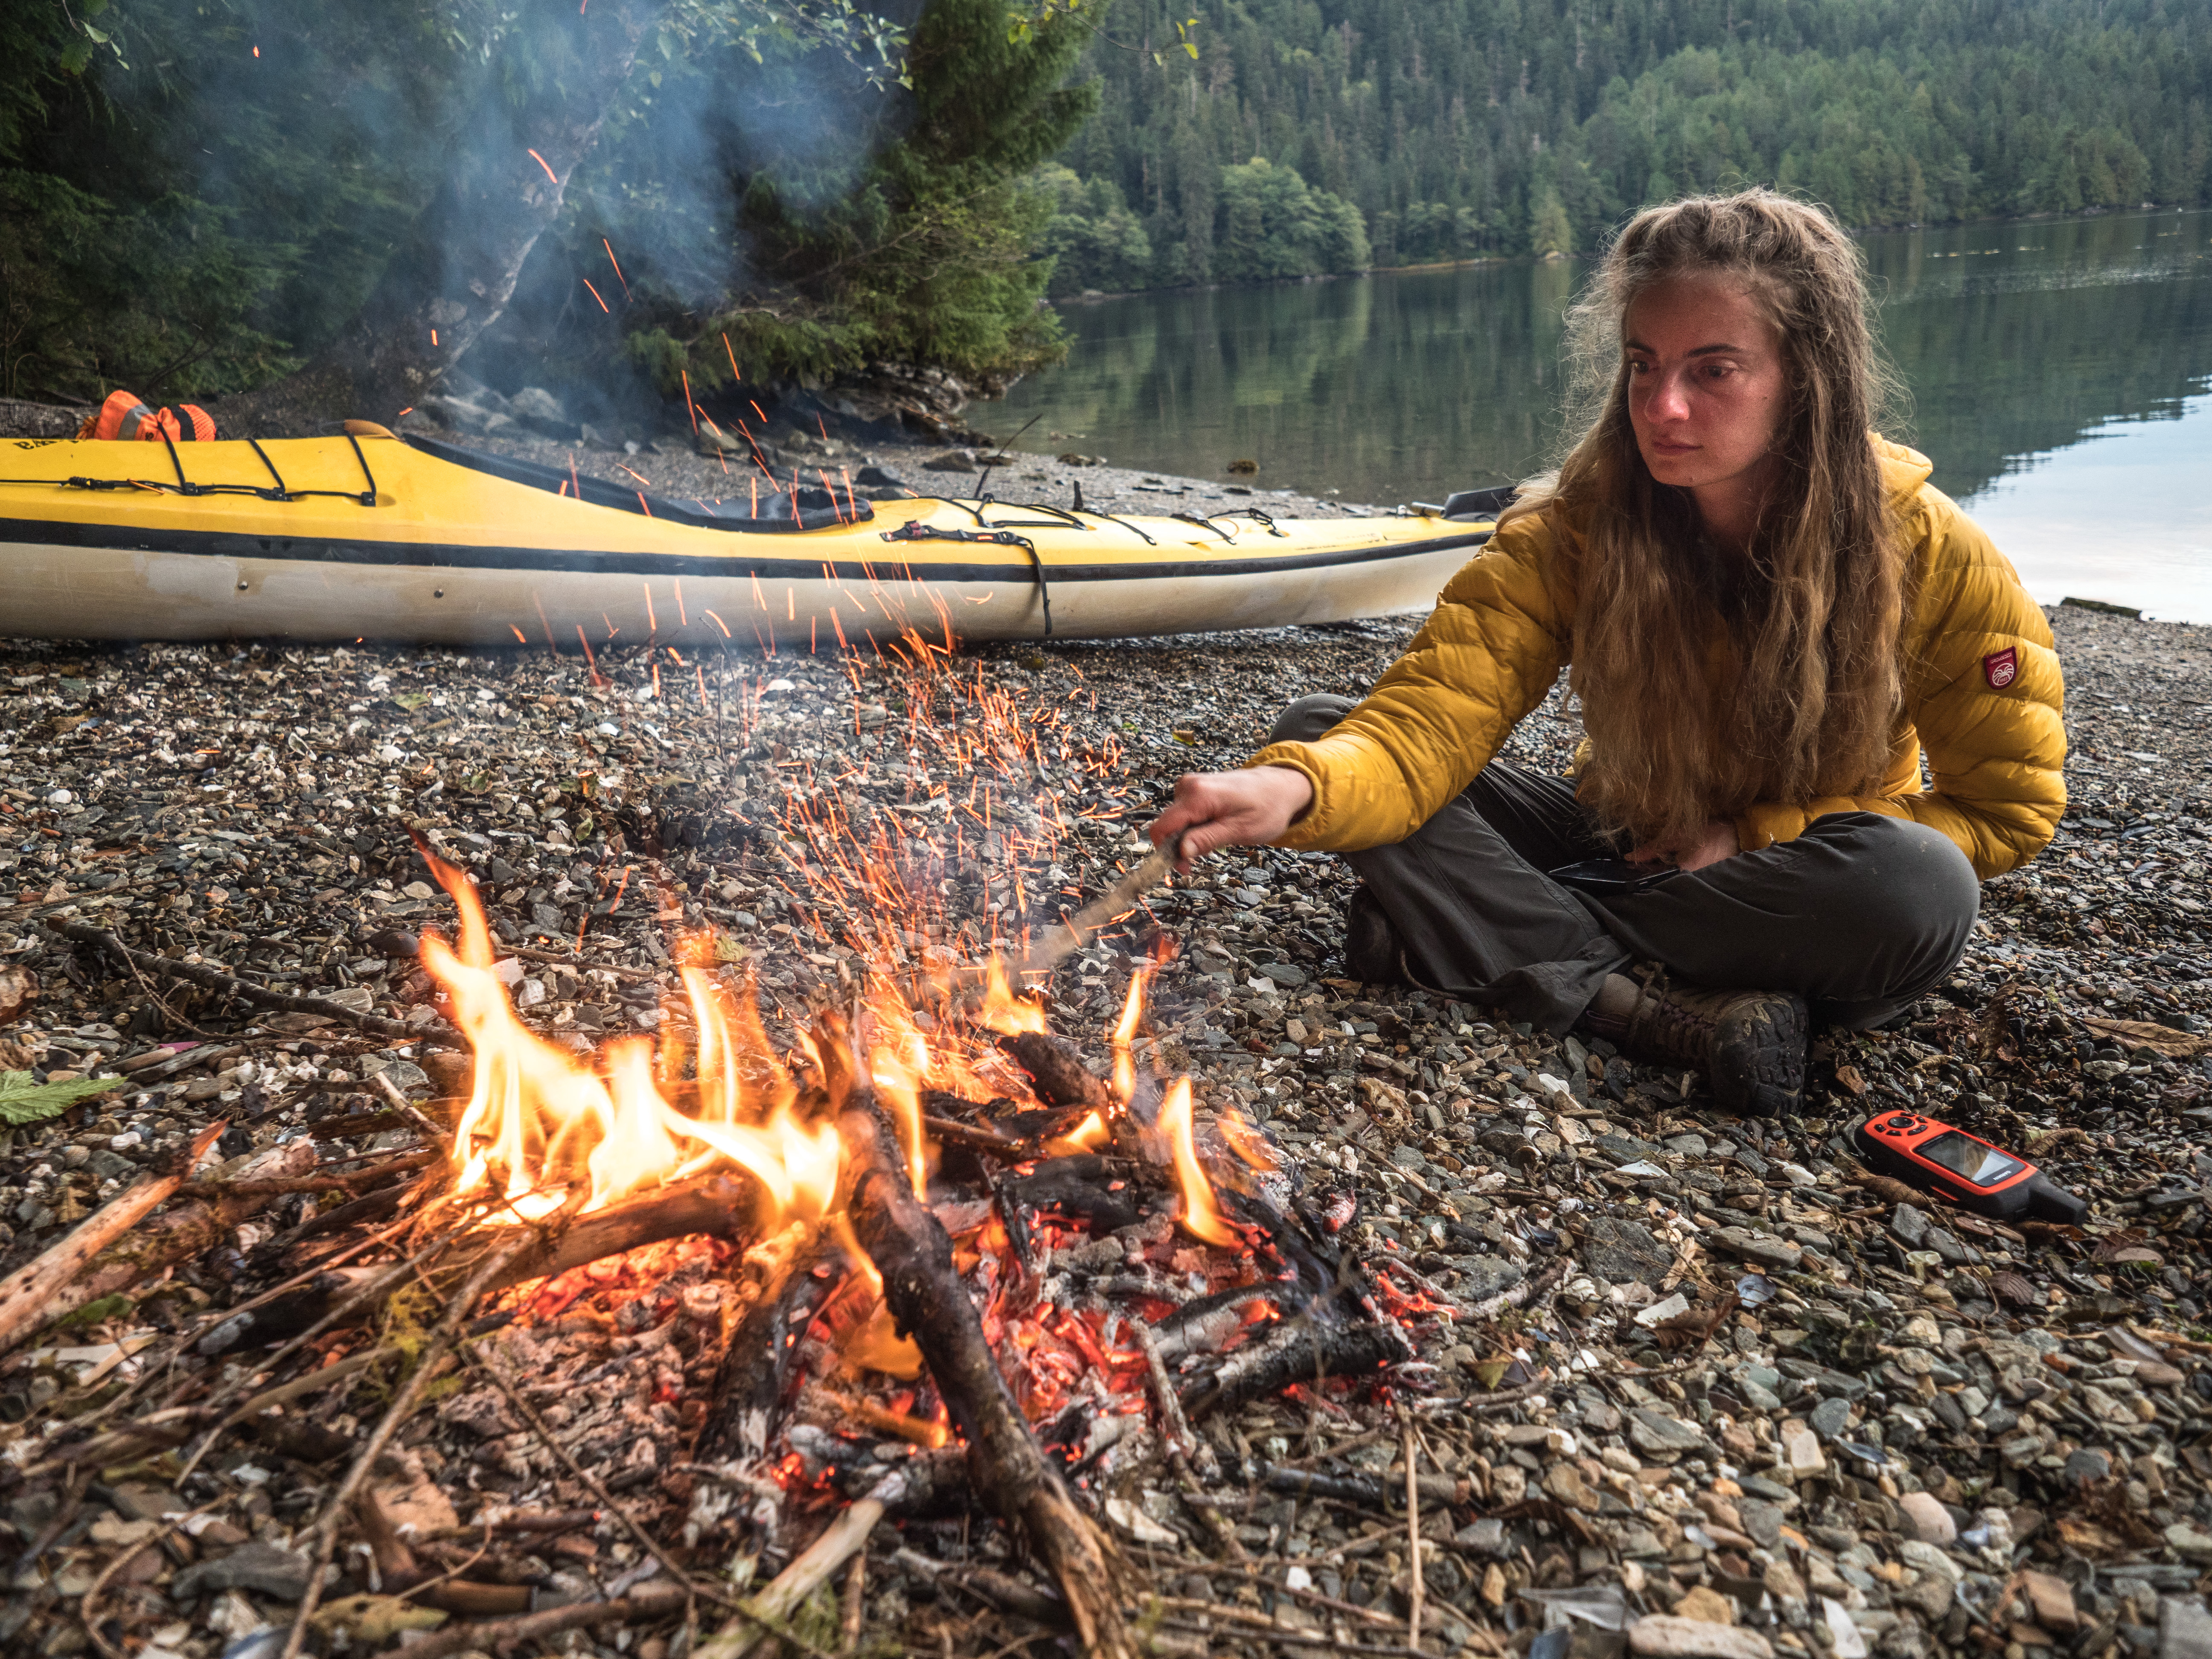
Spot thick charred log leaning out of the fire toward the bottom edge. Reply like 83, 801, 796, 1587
821, 1029, 1137, 1659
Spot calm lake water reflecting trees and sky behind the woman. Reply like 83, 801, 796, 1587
1000, 212, 2212, 622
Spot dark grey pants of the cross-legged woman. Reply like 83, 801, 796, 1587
1272, 693, 1982, 1033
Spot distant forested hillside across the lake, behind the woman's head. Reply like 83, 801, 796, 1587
1044, 0, 2212, 292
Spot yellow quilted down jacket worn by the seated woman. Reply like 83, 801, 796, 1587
1248, 438, 2066, 878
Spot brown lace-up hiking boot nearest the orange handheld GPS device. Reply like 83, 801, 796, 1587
1584, 973, 1812, 1117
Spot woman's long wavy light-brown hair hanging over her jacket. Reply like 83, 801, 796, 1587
1504, 190, 1909, 845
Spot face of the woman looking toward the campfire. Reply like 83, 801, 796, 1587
1621, 276, 1787, 520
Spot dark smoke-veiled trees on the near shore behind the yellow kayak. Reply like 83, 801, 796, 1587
0, 0, 1088, 418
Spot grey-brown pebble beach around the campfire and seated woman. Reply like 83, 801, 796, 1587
0, 418, 2212, 1659
